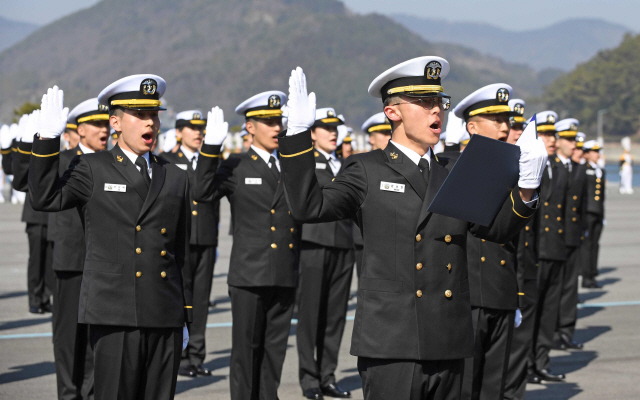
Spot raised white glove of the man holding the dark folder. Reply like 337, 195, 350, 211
287, 67, 316, 136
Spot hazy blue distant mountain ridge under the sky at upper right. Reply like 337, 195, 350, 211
392, 14, 630, 71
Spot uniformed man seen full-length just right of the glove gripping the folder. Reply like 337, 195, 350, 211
529, 111, 569, 383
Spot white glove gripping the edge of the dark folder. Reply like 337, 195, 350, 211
516, 121, 547, 189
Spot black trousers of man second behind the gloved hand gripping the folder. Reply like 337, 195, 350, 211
555, 247, 581, 339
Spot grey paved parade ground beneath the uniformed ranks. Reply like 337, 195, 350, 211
0, 187, 640, 400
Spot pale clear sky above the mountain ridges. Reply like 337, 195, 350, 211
0, 0, 640, 32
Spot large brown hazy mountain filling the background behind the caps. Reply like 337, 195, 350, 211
0, 0, 549, 126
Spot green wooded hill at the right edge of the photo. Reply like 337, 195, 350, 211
542, 34, 640, 139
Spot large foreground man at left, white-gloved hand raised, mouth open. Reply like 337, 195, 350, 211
29, 78, 192, 399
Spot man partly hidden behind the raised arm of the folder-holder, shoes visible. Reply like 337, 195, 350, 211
296, 108, 354, 399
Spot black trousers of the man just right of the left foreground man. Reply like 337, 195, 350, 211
181, 245, 216, 366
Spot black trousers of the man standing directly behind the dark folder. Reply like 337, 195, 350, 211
460, 307, 515, 400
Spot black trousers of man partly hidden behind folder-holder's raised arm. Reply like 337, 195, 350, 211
296, 243, 354, 391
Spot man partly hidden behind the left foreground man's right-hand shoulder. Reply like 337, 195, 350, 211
162, 110, 220, 378
